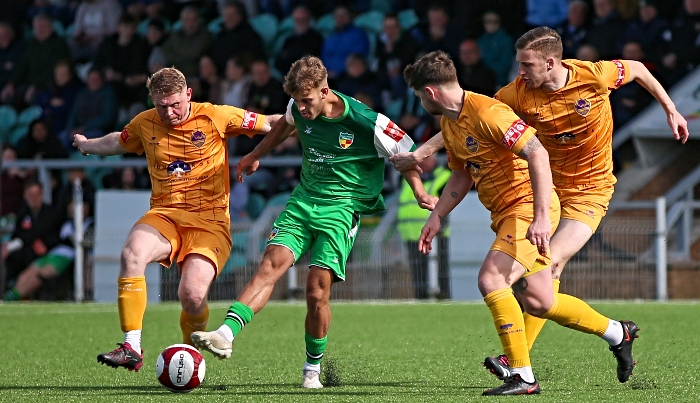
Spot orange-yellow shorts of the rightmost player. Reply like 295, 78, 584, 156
555, 184, 615, 232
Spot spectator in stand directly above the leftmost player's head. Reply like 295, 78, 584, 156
163, 6, 212, 77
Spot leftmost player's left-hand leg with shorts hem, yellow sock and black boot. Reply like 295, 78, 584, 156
97, 215, 174, 371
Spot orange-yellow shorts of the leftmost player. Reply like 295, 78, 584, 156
136, 208, 231, 276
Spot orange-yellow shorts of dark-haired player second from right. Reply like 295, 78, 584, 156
491, 194, 560, 277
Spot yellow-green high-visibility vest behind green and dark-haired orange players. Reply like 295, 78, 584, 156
396, 167, 452, 241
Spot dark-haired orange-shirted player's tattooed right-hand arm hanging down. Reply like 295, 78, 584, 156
518, 136, 552, 255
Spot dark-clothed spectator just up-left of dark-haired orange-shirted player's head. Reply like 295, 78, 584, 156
375, 14, 418, 99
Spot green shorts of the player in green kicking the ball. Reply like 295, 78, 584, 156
267, 196, 360, 281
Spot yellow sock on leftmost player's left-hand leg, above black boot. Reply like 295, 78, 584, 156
117, 276, 148, 332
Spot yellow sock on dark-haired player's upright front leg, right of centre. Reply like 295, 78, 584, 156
484, 288, 531, 368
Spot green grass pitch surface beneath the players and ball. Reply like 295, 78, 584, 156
0, 302, 700, 403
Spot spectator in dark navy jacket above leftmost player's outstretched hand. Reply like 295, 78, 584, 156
59, 69, 118, 152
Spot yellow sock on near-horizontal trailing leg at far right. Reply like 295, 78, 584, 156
542, 294, 610, 337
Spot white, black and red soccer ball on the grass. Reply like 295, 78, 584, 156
156, 344, 207, 393
